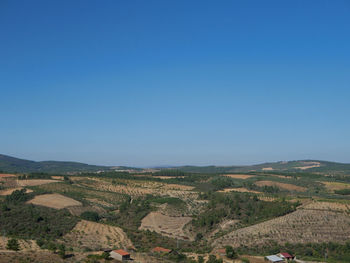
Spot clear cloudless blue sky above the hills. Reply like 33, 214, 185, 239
0, 0, 350, 166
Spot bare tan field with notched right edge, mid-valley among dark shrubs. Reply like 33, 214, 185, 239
140, 212, 193, 240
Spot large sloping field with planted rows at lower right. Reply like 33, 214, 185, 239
214, 209, 350, 247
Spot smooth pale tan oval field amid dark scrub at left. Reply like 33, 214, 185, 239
28, 194, 82, 209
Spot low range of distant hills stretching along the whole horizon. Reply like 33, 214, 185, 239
0, 154, 350, 175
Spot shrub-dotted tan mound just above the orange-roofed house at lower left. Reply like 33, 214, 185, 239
63, 220, 133, 250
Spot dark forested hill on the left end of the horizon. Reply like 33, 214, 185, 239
0, 154, 110, 173
